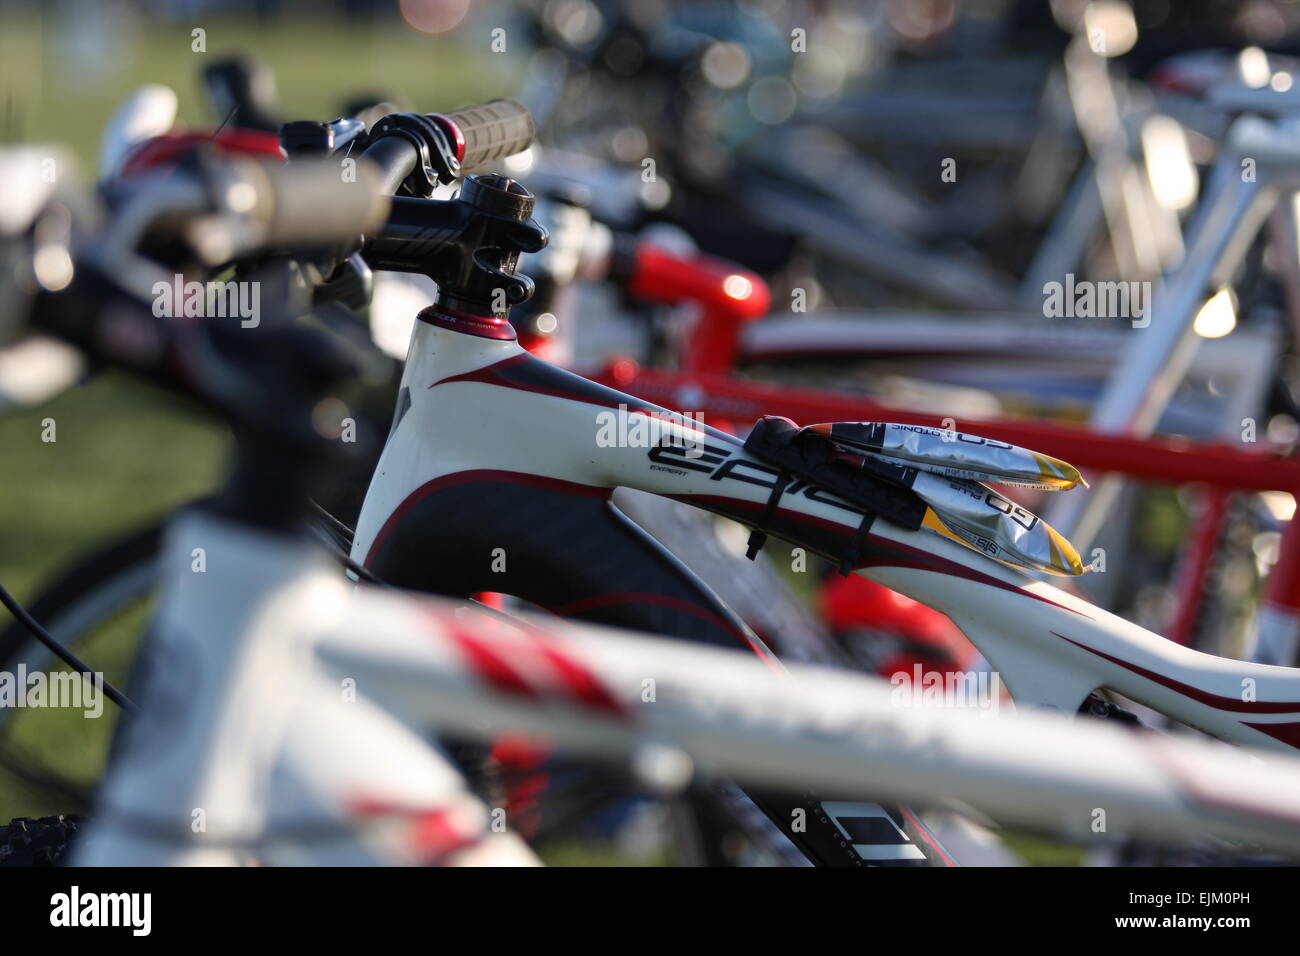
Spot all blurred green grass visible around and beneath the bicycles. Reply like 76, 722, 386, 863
0, 9, 1080, 865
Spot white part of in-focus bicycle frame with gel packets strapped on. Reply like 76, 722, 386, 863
352, 313, 1300, 749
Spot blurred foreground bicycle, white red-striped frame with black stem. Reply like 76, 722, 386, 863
7, 141, 1300, 864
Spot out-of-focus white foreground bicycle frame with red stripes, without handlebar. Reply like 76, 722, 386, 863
74, 510, 1300, 865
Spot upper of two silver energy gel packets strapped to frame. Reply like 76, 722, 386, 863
809, 421, 1088, 492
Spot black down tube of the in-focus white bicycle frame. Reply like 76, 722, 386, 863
364, 480, 953, 866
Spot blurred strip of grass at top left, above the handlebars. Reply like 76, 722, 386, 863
0, 10, 523, 169
